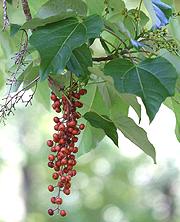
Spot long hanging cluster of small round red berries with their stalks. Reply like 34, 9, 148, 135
47, 86, 87, 217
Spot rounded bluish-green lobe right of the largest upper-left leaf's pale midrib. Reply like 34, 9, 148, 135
84, 15, 104, 39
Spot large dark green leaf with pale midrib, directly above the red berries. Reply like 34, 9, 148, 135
30, 18, 87, 80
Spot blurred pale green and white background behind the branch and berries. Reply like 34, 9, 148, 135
0, 0, 180, 222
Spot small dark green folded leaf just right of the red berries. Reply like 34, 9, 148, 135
84, 112, 118, 146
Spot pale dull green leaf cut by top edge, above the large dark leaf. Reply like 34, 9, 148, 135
36, 0, 87, 19
